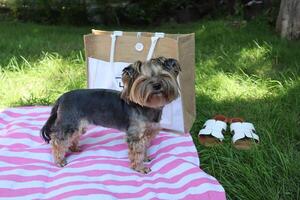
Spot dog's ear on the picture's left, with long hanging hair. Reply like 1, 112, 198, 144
121, 61, 142, 101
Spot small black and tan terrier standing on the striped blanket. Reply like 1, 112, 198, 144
41, 57, 181, 174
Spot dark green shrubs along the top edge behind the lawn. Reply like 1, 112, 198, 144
0, 0, 280, 25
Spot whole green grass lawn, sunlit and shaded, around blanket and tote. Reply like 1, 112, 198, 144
0, 20, 300, 200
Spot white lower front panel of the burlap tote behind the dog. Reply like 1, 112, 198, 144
88, 58, 184, 132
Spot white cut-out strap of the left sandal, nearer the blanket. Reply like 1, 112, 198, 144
199, 119, 227, 141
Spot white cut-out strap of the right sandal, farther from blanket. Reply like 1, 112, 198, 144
230, 122, 259, 143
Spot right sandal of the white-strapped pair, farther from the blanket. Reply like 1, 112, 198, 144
230, 118, 259, 150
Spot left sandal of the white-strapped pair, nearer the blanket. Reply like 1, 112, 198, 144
198, 115, 227, 146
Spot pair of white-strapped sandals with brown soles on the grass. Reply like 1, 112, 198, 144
198, 115, 259, 150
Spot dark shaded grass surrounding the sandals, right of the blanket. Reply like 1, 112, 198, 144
191, 82, 300, 199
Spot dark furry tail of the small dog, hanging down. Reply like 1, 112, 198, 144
41, 100, 59, 143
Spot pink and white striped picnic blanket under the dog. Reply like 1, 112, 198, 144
0, 107, 225, 200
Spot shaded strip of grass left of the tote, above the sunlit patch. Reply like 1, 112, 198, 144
0, 22, 90, 70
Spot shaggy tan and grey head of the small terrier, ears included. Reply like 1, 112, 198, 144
121, 57, 181, 108
